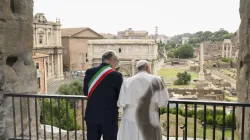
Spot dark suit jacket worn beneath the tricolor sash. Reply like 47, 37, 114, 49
83, 63, 123, 124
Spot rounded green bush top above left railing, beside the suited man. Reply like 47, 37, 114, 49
57, 81, 83, 95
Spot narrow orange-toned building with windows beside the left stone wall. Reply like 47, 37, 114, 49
32, 53, 49, 94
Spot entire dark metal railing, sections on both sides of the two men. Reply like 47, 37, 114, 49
5, 94, 250, 140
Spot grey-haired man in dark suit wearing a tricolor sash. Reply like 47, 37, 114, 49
84, 51, 123, 140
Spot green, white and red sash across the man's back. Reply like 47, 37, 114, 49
88, 65, 114, 98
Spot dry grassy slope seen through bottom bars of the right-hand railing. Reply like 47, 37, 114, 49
161, 114, 238, 140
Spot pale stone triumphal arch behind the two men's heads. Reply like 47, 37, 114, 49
88, 39, 158, 76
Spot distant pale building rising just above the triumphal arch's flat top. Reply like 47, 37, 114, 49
117, 28, 148, 39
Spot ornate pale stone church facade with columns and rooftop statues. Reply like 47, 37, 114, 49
33, 13, 64, 81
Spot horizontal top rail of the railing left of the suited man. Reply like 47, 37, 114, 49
4, 93, 88, 100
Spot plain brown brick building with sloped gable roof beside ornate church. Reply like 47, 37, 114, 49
62, 28, 103, 71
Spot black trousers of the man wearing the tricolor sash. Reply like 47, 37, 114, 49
87, 122, 118, 140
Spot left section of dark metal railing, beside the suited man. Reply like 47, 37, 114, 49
5, 93, 87, 140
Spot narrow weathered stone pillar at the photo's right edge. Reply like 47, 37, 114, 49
236, 0, 250, 140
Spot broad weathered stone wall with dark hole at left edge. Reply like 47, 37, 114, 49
0, 0, 36, 140
